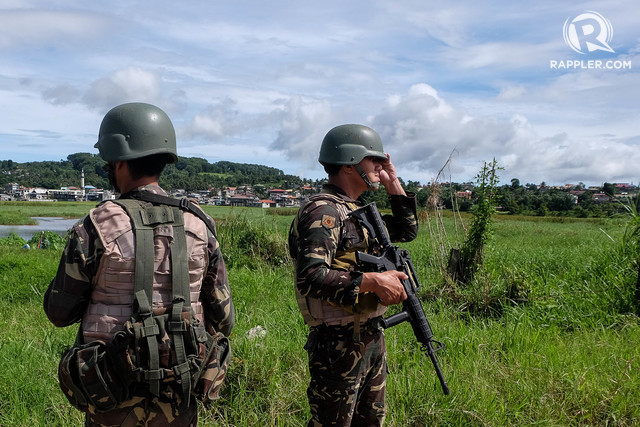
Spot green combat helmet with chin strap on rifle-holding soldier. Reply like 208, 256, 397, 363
318, 124, 387, 189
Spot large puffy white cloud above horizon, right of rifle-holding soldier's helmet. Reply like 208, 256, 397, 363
364, 84, 640, 183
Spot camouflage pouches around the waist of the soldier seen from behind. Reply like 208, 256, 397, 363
58, 316, 231, 412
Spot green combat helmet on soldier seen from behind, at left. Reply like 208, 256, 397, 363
95, 102, 178, 163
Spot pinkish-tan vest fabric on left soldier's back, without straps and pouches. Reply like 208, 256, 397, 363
82, 200, 208, 342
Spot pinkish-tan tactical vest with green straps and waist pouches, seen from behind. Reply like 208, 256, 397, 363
58, 196, 231, 412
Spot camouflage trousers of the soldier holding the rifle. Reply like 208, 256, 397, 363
305, 325, 387, 426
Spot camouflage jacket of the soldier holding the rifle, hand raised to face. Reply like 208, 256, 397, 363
289, 185, 418, 306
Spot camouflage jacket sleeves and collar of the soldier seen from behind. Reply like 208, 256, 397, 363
44, 186, 235, 336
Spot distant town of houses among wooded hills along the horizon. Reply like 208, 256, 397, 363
0, 153, 640, 218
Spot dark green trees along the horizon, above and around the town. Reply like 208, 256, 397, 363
0, 153, 638, 218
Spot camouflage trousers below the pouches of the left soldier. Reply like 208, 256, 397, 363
85, 384, 198, 427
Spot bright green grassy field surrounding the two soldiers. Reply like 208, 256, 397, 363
0, 205, 640, 426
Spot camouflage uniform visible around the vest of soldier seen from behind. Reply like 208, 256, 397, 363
44, 185, 234, 426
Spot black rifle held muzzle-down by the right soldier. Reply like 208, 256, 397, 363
349, 202, 449, 395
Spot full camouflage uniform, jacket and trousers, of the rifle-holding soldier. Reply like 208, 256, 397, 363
290, 185, 418, 426
